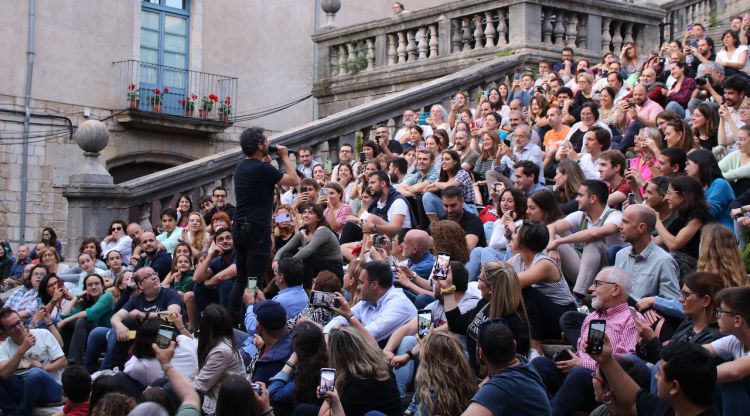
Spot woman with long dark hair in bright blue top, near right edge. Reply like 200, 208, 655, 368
685, 149, 734, 230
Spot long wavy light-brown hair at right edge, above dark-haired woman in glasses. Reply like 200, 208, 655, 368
696, 223, 747, 287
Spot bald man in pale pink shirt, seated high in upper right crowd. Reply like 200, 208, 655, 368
613, 84, 664, 153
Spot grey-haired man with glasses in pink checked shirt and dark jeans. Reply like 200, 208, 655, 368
531, 267, 638, 415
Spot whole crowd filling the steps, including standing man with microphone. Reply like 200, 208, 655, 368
0, 14, 750, 416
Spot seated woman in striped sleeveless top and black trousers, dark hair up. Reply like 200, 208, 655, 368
508, 221, 576, 353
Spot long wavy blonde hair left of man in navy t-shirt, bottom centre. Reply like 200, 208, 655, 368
414, 330, 477, 415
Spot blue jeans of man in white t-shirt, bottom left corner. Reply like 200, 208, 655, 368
0, 368, 62, 415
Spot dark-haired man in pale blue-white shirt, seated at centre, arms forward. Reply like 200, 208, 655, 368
323, 261, 417, 345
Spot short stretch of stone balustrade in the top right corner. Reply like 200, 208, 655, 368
662, 0, 750, 44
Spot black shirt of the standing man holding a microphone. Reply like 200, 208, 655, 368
233, 159, 284, 232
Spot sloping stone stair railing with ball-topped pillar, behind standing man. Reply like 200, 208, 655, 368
63, 54, 527, 255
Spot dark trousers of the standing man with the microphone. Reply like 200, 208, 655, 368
235, 223, 271, 327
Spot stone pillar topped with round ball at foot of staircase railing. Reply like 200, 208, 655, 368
63, 120, 128, 258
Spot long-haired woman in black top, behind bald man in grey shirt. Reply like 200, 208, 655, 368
655, 176, 715, 275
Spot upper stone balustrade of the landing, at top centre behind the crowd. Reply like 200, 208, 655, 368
312, 0, 664, 116
